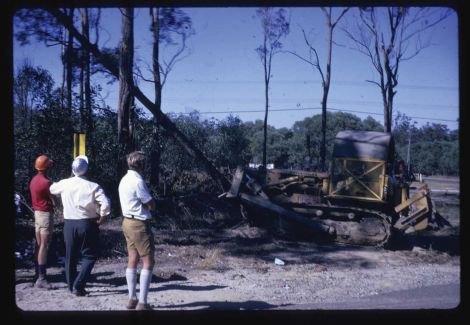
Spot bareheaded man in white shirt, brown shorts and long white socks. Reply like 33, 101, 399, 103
119, 151, 155, 310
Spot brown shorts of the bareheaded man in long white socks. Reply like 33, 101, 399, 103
122, 217, 155, 256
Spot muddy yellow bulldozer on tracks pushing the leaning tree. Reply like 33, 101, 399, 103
226, 131, 446, 246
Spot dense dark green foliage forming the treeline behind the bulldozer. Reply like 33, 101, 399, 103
14, 65, 459, 211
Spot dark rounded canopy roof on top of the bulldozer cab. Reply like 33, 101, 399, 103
333, 130, 394, 161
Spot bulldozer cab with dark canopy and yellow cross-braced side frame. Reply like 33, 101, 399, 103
328, 131, 394, 202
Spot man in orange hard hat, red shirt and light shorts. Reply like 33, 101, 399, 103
29, 155, 54, 289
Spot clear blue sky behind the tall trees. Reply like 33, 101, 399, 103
14, 7, 459, 130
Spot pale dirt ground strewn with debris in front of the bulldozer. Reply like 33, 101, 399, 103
15, 190, 461, 311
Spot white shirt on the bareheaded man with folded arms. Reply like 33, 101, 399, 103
119, 170, 152, 220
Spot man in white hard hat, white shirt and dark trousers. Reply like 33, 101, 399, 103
49, 156, 110, 296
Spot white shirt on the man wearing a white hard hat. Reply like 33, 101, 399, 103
49, 176, 111, 220
